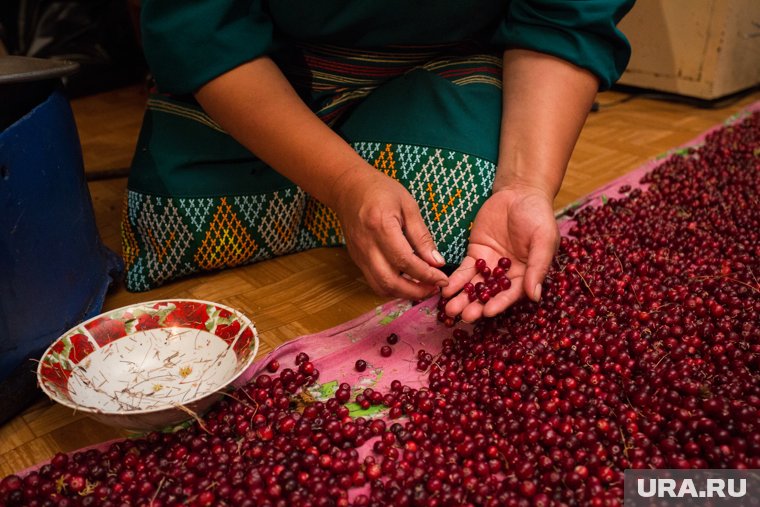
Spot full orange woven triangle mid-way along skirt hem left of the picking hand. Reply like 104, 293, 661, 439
195, 197, 259, 269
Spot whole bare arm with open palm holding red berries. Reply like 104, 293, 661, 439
434, 49, 599, 322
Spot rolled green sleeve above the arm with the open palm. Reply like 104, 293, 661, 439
494, 0, 634, 90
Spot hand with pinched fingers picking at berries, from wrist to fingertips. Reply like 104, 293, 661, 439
330, 167, 448, 299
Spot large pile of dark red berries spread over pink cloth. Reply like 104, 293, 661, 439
0, 110, 760, 507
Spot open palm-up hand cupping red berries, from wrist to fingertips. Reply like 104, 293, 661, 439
442, 187, 559, 322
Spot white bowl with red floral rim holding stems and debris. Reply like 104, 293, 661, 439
37, 299, 259, 431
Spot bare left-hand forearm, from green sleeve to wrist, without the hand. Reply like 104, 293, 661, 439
196, 57, 369, 206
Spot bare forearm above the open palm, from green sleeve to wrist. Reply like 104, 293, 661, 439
493, 49, 599, 199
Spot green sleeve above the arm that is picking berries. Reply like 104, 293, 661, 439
141, 0, 272, 94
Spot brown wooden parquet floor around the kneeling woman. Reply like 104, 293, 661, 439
0, 82, 760, 477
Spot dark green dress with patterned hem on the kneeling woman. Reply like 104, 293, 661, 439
122, 0, 633, 291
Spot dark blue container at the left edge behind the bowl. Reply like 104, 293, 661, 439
0, 61, 123, 398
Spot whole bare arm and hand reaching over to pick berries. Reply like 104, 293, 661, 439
195, 57, 447, 299
